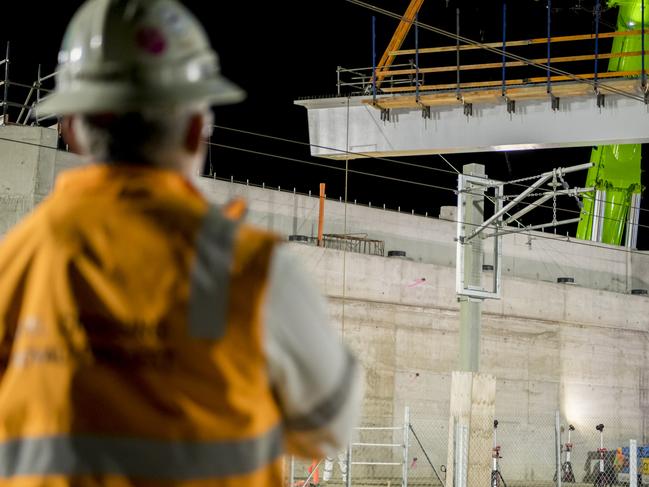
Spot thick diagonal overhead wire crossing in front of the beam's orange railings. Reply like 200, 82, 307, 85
345, 0, 645, 103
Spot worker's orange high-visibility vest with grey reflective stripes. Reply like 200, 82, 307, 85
0, 165, 283, 487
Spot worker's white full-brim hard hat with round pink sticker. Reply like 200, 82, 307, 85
36, 0, 245, 117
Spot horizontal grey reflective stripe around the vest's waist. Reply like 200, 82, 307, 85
0, 427, 283, 480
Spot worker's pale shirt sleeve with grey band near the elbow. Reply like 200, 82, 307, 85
265, 245, 362, 454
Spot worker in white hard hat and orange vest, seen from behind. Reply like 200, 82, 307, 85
0, 0, 360, 487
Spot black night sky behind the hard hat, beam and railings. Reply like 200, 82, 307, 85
0, 0, 649, 249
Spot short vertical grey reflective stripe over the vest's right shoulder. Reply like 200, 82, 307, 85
189, 206, 237, 340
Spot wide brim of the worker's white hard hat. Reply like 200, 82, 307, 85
36, 76, 246, 118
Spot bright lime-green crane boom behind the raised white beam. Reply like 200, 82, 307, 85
577, 0, 649, 245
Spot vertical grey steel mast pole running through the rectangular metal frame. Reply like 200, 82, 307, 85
458, 164, 485, 372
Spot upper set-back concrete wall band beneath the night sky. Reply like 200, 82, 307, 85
197, 178, 649, 292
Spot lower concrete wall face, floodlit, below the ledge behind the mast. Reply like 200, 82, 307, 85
292, 244, 649, 480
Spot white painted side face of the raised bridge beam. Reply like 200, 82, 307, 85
296, 95, 649, 159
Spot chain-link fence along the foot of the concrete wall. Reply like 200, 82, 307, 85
286, 408, 649, 487
